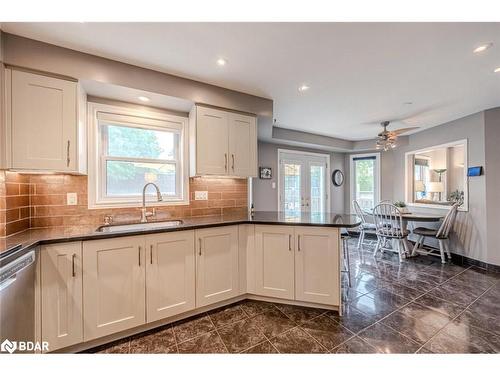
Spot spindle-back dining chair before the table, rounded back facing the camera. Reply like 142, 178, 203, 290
373, 203, 408, 262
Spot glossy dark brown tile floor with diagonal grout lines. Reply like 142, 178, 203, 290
87, 239, 500, 353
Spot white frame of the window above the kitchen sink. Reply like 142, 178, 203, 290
88, 102, 189, 209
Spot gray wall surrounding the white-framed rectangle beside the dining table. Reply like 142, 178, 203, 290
390, 112, 492, 264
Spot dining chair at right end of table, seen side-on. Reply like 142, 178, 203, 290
411, 203, 459, 263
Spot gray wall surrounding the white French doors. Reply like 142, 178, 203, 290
252, 142, 345, 213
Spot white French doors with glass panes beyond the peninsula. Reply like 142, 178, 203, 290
278, 150, 330, 216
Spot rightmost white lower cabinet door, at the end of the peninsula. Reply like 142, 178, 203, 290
295, 227, 340, 306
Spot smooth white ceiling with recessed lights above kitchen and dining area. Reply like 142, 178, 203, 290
2, 23, 500, 140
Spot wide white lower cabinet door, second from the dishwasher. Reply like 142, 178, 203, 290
83, 236, 146, 341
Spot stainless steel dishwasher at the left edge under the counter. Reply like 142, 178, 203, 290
0, 249, 38, 353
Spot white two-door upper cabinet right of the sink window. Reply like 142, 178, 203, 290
189, 105, 257, 177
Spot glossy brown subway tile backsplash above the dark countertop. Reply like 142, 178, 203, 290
0, 171, 248, 236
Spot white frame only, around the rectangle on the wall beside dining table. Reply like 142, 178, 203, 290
405, 139, 469, 211
